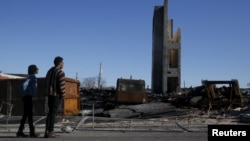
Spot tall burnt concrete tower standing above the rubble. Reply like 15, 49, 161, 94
151, 0, 181, 94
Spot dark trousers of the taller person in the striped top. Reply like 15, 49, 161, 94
46, 96, 61, 132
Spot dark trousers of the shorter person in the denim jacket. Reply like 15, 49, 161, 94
18, 95, 34, 133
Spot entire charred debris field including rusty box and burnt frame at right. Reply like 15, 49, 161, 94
80, 79, 250, 123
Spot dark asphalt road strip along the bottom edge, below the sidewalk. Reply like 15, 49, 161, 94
0, 131, 207, 141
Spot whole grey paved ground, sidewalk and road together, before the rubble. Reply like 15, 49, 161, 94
0, 114, 244, 141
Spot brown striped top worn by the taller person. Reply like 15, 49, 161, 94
45, 67, 65, 97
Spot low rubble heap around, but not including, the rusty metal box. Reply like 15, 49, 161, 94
78, 86, 250, 123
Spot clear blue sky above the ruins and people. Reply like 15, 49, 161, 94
0, 0, 250, 87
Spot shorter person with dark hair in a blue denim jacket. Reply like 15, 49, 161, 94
16, 64, 38, 138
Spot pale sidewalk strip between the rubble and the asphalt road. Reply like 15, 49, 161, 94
0, 116, 247, 134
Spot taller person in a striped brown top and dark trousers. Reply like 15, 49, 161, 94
44, 56, 65, 138
